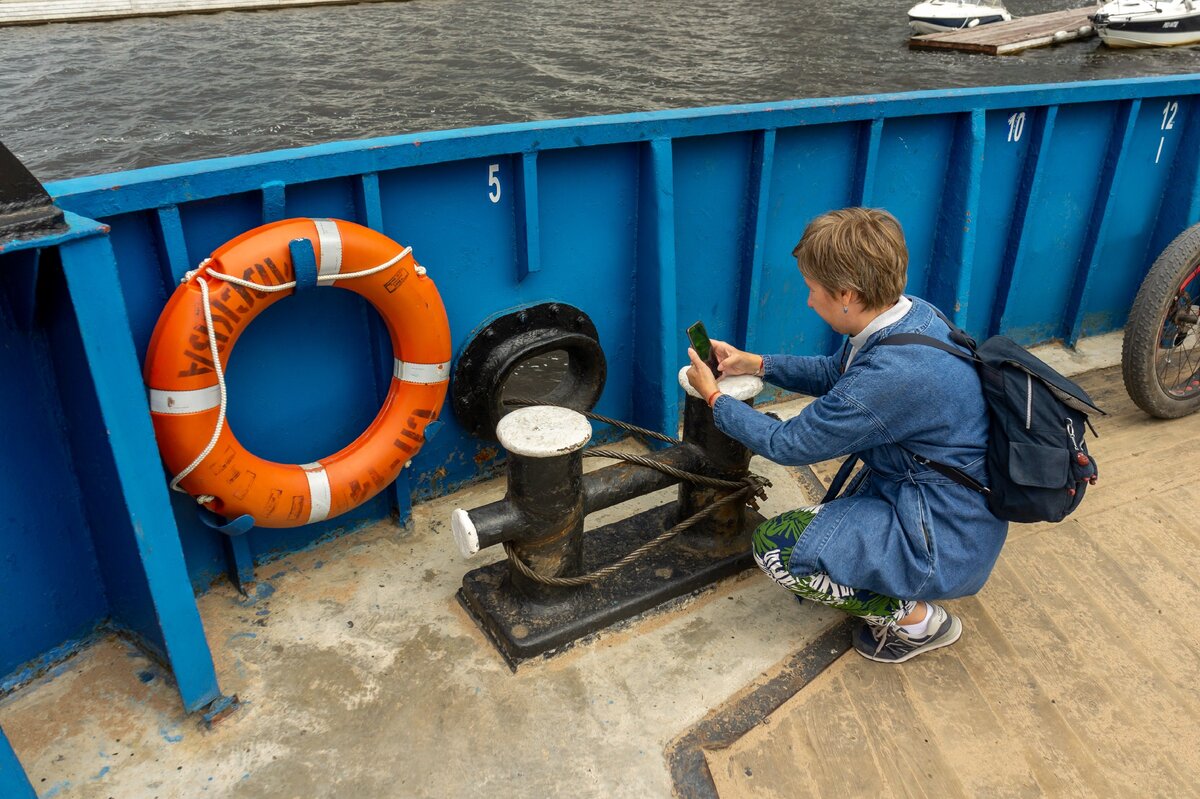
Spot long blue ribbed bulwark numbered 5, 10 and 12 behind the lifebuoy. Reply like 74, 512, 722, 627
35, 76, 1200, 595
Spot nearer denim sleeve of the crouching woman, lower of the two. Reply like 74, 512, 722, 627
713, 383, 893, 465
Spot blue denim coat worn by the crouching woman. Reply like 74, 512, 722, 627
713, 298, 1008, 600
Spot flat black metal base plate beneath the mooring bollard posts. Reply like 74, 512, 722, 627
458, 503, 763, 669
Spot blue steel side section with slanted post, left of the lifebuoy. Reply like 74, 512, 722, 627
0, 214, 221, 710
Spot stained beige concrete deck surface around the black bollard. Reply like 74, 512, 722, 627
0, 336, 1132, 799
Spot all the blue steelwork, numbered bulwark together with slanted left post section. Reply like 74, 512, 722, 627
0, 76, 1200, 703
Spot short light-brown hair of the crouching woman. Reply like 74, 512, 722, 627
792, 208, 908, 311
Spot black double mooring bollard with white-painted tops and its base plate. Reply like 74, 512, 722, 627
451, 378, 762, 668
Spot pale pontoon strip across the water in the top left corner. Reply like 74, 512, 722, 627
0, 0, 400, 26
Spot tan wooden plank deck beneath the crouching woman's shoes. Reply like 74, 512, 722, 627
706, 368, 1200, 799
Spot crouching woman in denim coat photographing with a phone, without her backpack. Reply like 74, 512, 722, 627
688, 208, 1008, 663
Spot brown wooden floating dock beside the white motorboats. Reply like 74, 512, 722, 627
908, 6, 1096, 55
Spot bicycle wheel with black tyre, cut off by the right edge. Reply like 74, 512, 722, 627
1121, 219, 1200, 419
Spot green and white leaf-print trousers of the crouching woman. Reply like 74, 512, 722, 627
754, 505, 917, 625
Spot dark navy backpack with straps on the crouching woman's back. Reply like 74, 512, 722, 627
826, 313, 1105, 522
